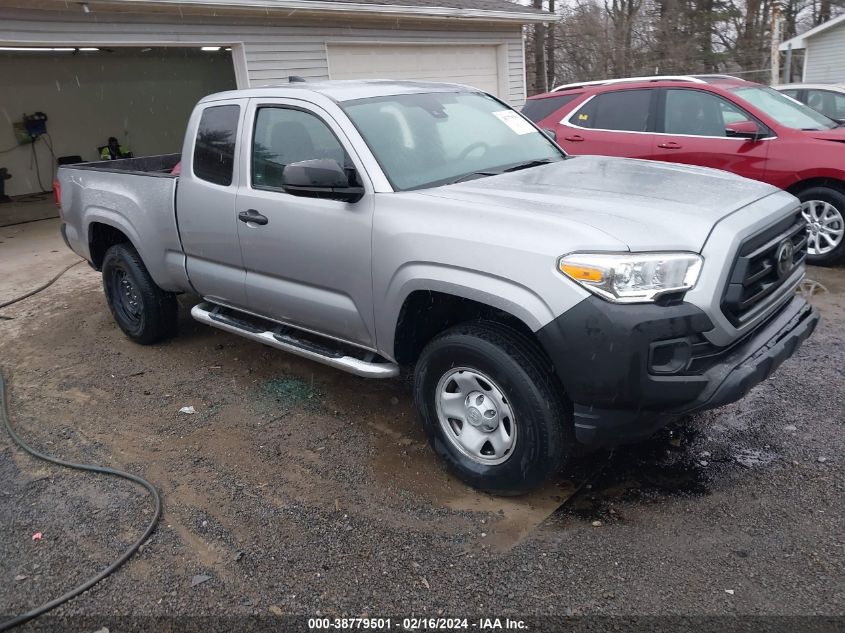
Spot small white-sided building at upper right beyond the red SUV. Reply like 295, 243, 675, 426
780, 15, 845, 83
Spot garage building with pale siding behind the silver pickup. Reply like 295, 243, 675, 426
0, 0, 552, 195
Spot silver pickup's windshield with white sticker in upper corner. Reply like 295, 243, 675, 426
341, 92, 565, 191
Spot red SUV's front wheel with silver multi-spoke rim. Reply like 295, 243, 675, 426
798, 187, 845, 266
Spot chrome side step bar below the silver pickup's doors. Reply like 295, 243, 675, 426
191, 302, 399, 378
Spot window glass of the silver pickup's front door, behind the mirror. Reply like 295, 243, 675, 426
252, 106, 351, 189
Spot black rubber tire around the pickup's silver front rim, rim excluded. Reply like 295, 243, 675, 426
414, 322, 575, 495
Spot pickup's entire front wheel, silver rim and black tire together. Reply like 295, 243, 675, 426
414, 322, 574, 495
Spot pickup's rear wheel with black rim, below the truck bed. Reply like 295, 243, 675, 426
102, 244, 178, 345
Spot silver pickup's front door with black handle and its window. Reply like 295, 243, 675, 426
236, 99, 375, 347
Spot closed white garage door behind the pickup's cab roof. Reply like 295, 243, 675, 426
328, 44, 499, 95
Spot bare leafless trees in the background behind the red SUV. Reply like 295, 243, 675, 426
526, 0, 845, 94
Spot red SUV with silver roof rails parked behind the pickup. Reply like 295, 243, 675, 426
522, 75, 845, 265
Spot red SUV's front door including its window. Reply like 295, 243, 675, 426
652, 88, 770, 180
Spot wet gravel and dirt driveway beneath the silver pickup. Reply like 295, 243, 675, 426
0, 221, 845, 631
